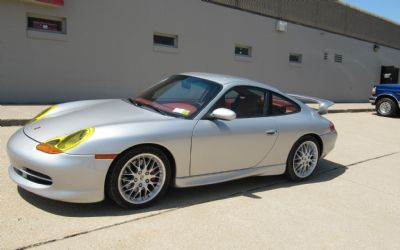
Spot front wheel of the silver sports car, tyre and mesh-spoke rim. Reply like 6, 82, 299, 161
106, 147, 171, 209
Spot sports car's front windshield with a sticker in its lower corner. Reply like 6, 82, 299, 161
131, 75, 222, 119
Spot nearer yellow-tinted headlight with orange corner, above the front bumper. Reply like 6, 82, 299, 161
36, 128, 94, 154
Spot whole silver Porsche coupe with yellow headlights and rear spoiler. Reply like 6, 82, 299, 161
7, 73, 337, 208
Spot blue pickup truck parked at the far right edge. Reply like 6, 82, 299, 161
369, 84, 400, 116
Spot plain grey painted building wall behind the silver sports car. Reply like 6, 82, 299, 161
0, 0, 400, 103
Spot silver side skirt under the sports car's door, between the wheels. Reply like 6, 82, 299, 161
174, 164, 286, 188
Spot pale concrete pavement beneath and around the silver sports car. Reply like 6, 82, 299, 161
0, 112, 400, 249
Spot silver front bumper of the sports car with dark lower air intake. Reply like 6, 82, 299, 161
7, 128, 112, 203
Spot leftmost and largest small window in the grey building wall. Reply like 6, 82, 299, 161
27, 15, 66, 34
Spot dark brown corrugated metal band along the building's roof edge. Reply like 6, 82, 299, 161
202, 0, 400, 49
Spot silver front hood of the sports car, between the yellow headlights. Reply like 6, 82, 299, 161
24, 99, 176, 142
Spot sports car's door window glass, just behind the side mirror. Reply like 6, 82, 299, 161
216, 86, 266, 118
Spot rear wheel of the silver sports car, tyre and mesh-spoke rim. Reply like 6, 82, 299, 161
285, 135, 321, 181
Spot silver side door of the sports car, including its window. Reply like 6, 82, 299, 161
190, 86, 278, 175
